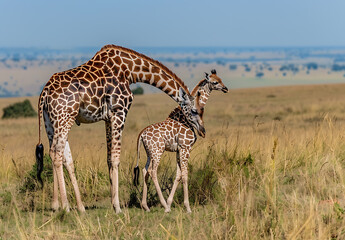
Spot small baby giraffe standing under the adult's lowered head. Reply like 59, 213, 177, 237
134, 70, 228, 213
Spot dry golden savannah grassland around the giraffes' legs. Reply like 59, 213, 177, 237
0, 84, 345, 239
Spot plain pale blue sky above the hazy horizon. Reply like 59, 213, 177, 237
0, 0, 345, 48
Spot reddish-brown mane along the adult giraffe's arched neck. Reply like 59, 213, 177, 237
95, 44, 190, 95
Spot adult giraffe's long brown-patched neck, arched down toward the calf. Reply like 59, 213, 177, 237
91, 45, 190, 102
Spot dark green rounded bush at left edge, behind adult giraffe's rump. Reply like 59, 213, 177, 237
2, 100, 37, 119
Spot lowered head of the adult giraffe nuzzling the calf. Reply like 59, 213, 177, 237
179, 88, 206, 137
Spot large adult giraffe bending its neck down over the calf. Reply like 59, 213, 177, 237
36, 45, 205, 213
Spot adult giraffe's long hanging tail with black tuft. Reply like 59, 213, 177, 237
36, 89, 46, 188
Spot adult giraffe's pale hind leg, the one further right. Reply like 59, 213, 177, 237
64, 141, 85, 212
